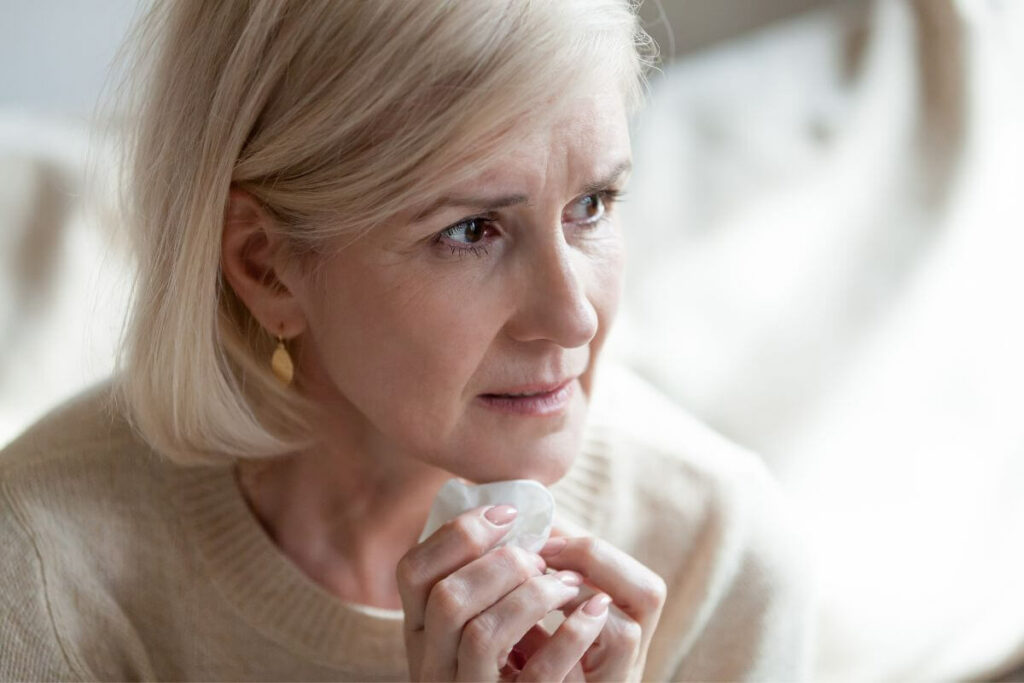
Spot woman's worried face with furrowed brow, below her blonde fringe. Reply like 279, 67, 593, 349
284, 94, 631, 483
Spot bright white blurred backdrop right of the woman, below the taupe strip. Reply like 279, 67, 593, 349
615, 0, 1024, 681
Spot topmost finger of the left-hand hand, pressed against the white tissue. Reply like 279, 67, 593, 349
395, 505, 515, 631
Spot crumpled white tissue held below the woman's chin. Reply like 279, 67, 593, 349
420, 479, 555, 553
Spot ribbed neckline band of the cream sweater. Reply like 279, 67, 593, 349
171, 429, 611, 679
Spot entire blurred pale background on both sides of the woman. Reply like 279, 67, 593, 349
0, 0, 1024, 681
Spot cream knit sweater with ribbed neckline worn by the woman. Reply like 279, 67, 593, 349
0, 368, 810, 681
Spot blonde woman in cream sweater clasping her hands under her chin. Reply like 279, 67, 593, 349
0, 0, 804, 680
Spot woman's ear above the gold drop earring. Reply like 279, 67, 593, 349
220, 188, 306, 339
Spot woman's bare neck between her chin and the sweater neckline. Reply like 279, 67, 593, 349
237, 438, 452, 609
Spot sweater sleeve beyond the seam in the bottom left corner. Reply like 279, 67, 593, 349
0, 483, 81, 681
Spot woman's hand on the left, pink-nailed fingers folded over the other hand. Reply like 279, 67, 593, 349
396, 505, 607, 681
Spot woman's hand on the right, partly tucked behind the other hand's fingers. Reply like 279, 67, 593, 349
507, 529, 667, 681
